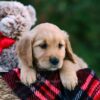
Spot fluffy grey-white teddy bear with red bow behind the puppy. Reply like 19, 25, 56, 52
0, 1, 36, 72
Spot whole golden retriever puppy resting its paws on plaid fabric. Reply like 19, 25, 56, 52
17, 23, 87, 90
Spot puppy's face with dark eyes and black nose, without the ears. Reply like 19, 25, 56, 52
33, 30, 65, 70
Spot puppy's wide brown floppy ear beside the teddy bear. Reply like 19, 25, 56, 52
16, 35, 32, 67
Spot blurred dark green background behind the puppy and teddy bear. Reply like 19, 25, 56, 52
10, 0, 100, 76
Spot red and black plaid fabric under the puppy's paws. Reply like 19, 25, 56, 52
0, 68, 100, 100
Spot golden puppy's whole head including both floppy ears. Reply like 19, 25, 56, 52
17, 23, 75, 70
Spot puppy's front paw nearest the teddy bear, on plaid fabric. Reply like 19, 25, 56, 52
20, 69, 36, 85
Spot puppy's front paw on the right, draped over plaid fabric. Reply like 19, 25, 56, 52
60, 72, 78, 91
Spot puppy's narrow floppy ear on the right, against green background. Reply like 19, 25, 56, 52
62, 31, 76, 63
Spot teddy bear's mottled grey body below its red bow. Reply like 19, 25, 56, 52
0, 44, 18, 72
